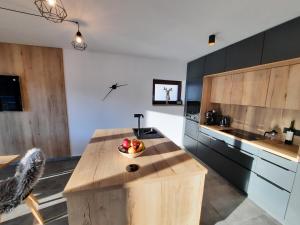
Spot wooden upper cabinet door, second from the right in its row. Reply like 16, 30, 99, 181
266, 66, 289, 109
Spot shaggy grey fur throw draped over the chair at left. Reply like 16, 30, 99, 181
0, 148, 45, 214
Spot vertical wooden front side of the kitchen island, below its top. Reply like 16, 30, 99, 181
66, 173, 205, 225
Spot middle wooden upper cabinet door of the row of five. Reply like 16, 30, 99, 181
243, 69, 271, 107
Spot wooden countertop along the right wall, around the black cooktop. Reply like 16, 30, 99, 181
200, 125, 300, 162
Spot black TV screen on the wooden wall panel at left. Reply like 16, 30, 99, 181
0, 75, 23, 111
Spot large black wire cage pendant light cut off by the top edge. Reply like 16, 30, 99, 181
34, 0, 67, 23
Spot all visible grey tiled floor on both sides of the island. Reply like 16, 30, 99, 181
0, 159, 279, 225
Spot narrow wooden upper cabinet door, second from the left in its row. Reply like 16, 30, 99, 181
230, 73, 244, 105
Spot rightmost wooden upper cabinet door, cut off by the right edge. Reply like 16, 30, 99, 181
285, 64, 300, 110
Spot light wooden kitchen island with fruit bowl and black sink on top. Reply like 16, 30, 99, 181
64, 128, 207, 225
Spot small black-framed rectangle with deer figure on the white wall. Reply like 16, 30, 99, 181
152, 79, 182, 105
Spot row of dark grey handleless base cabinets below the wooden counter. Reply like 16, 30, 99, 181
184, 121, 300, 225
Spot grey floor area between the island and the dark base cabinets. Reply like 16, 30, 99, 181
200, 169, 280, 225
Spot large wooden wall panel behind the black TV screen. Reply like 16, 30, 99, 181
0, 43, 70, 157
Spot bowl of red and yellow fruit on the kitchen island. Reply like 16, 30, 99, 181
118, 138, 145, 158
